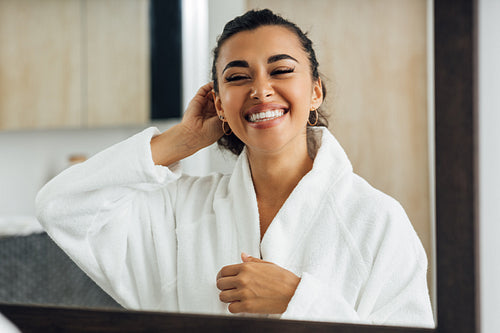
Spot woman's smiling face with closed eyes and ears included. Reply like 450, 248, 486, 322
215, 26, 322, 152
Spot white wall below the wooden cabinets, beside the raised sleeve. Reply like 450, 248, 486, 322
0, 122, 171, 227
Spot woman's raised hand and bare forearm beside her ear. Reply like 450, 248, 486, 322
151, 82, 223, 166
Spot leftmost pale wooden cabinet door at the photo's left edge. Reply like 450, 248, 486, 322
0, 0, 82, 130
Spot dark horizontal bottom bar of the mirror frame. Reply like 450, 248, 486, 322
0, 304, 434, 333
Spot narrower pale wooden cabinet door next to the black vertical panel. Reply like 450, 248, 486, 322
84, 0, 149, 126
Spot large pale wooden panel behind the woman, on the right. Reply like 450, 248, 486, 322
247, 0, 433, 289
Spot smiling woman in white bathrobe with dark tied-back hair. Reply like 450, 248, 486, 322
37, 10, 433, 326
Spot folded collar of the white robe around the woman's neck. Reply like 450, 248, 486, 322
228, 127, 352, 267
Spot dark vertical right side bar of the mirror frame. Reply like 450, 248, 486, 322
434, 0, 480, 333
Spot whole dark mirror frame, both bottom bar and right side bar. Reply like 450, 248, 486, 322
0, 0, 479, 333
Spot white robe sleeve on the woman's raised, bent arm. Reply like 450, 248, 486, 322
36, 128, 180, 310
